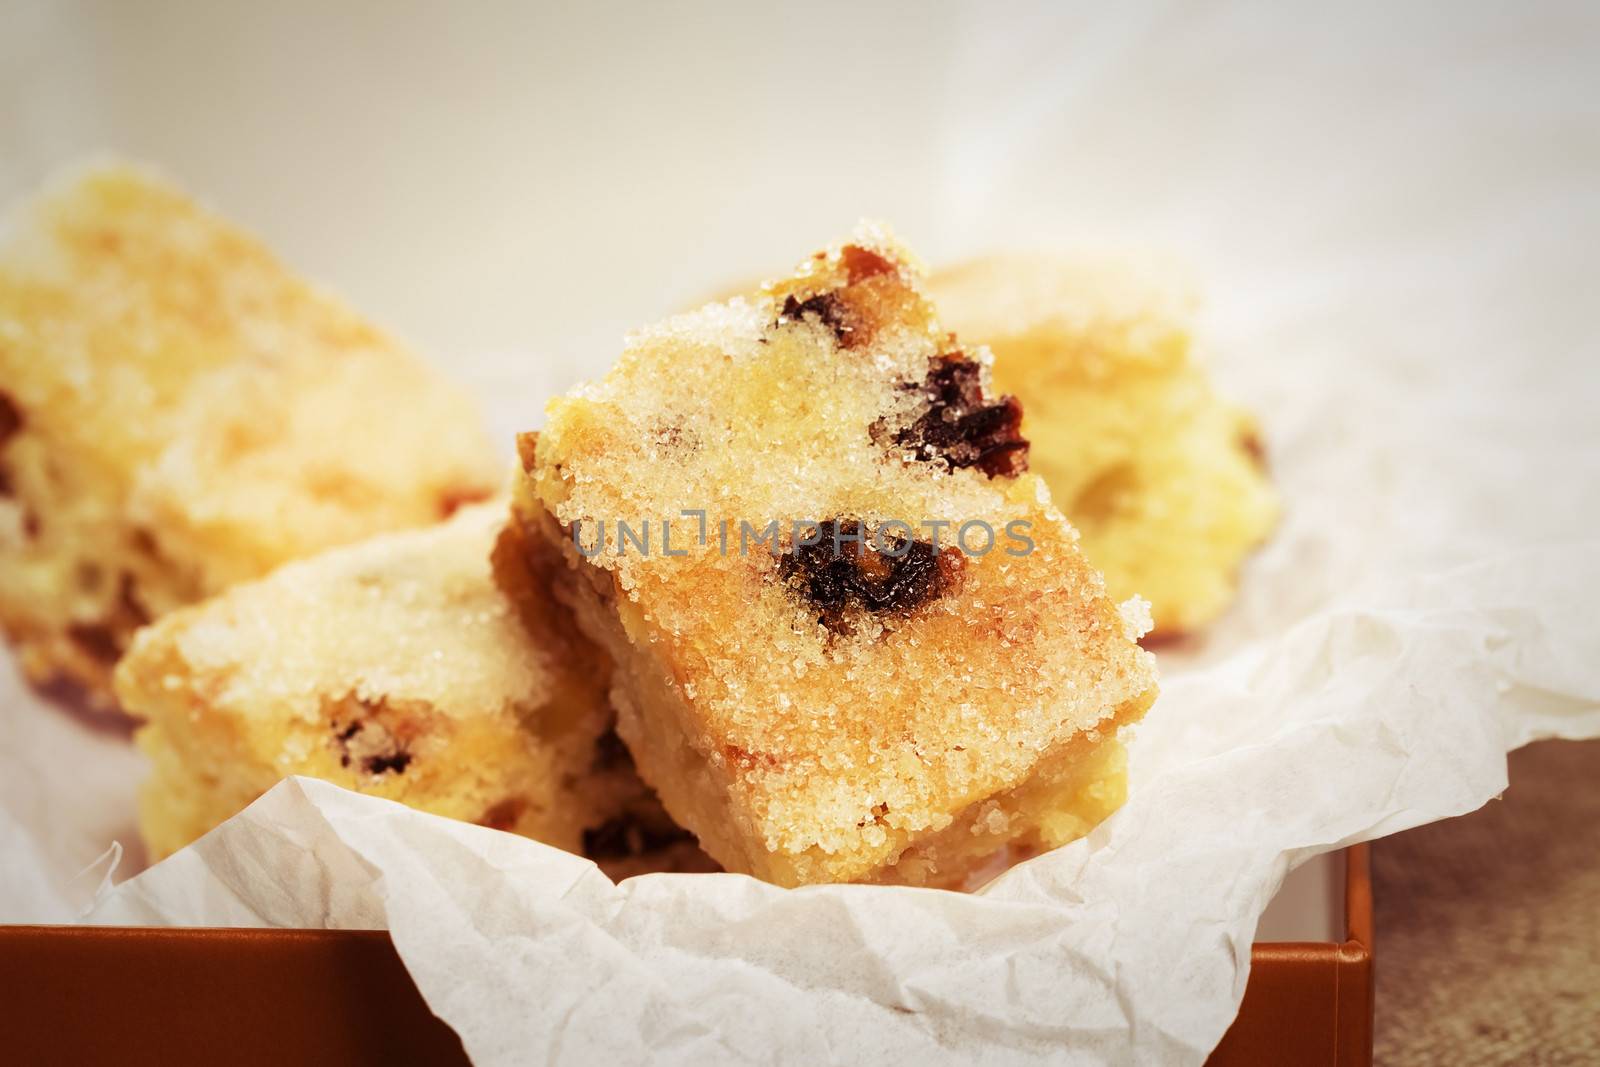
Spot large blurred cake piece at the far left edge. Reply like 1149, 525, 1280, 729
0, 166, 502, 707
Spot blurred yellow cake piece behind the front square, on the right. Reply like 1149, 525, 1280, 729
930, 256, 1278, 637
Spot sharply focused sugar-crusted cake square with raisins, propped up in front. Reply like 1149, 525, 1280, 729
517, 227, 1155, 885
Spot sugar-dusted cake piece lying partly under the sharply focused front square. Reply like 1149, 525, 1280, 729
115, 502, 617, 857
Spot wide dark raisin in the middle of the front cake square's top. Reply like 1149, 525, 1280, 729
778, 520, 960, 632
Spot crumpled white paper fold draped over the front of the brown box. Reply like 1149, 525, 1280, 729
81, 544, 1600, 1064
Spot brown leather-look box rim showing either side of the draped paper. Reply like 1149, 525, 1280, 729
0, 845, 1373, 1067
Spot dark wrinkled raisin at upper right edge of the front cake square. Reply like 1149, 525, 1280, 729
894, 352, 1027, 478
